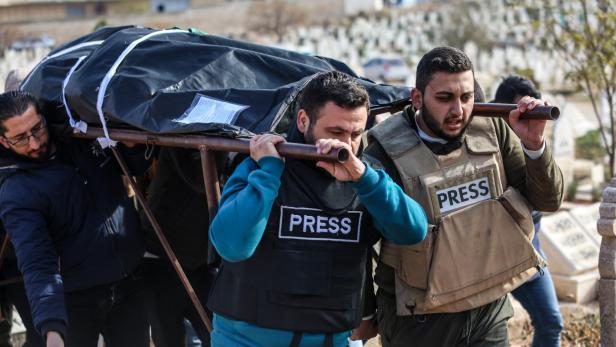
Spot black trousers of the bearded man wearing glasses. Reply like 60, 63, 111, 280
64, 273, 150, 347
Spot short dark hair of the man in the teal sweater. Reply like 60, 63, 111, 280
297, 71, 369, 125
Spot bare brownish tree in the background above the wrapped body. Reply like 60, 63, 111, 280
247, 0, 306, 43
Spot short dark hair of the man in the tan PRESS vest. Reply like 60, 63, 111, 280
415, 46, 475, 94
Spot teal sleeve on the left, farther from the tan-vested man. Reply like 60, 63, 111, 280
210, 157, 284, 262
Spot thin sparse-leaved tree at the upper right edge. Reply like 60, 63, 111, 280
535, 0, 616, 176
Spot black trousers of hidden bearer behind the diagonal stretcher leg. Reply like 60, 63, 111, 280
144, 258, 216, 347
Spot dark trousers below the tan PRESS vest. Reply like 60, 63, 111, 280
377, 293, 513, 347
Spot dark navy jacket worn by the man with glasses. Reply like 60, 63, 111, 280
0, 140, 148, 335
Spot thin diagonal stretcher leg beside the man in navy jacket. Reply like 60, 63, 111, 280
111, 147, 212, 333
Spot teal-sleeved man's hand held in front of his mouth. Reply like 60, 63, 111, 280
316, 139, 366, 182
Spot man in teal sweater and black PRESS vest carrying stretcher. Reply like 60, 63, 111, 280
208, 72, 427, 347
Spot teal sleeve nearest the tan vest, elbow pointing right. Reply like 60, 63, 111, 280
353, 165, 428, 245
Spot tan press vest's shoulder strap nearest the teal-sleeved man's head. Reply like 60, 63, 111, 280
368, 111, 420, 159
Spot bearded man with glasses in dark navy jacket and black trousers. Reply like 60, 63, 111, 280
0, 91, 149, 347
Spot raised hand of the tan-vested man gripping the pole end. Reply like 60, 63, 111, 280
509, 96, 549, 151
